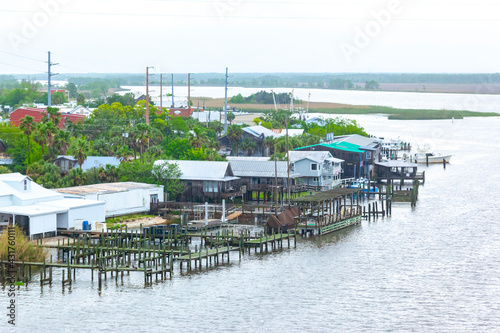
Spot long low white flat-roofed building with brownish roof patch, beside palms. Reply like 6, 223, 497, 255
56, 182, 164, 217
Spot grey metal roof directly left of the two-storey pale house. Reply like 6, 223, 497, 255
229, 160, 300, 178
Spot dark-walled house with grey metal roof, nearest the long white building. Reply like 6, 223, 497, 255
154, 160, 241, 202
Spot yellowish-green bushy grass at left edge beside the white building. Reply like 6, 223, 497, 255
0, 226, 47, 262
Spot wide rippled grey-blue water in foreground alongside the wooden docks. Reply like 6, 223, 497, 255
0, 116, 500, 332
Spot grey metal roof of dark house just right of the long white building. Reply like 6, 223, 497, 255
155, 160, 238, 181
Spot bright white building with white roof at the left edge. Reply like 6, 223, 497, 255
0, 173, 105, 238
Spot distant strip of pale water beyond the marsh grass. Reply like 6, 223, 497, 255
120, 86, 500, 112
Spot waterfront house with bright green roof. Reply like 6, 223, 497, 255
295, 141, 371, 178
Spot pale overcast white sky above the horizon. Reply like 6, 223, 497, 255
0, 0, 500, 74
